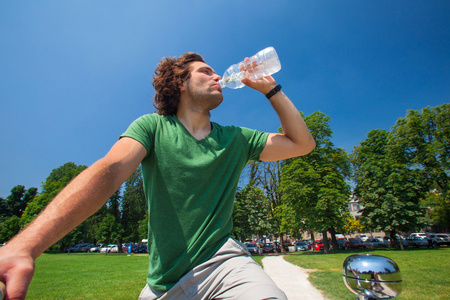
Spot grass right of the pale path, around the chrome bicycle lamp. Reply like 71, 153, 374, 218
285, 247, 450, 300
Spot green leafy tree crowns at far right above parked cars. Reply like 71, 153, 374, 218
352, 104, 450, 236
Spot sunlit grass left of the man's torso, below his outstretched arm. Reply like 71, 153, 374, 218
27, 253, 148, 299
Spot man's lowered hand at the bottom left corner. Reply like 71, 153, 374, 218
0, 246, 34, 299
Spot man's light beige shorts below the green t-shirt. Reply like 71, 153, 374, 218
139, 239, 287, 300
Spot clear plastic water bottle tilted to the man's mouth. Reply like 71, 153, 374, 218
219, 47, 281, 89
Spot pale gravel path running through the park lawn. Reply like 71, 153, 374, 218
262, 255, 326, 300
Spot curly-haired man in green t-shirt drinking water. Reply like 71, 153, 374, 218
0, 53, 315, 299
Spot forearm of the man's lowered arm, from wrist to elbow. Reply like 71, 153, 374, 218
7, 159, 121, 259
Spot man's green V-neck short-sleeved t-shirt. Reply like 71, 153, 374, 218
121, 114, 268, 291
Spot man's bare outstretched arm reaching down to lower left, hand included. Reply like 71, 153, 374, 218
0, 138, 146, 299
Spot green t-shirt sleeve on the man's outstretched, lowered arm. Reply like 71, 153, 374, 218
120, 114, 157, 154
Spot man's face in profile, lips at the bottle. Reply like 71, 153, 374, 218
182, 61, 223, 111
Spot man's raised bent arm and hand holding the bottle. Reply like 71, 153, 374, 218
242, 76, 316, 161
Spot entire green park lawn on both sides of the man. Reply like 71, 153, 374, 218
27, 247, 450, 300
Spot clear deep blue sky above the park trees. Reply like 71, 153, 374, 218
0, 0, 450, 197
